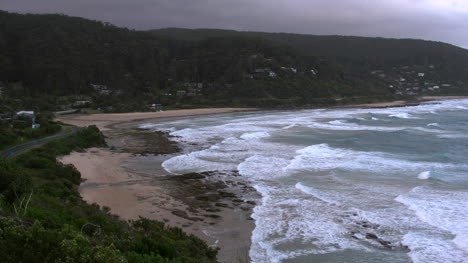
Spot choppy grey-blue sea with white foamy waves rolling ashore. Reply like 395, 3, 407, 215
142, 100, 468, 263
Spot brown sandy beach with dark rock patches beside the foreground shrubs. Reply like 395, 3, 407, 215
58, 109, 260, 263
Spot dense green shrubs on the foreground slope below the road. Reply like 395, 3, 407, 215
0, 126, 217, 263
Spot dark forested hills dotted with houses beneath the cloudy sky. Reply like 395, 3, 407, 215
0, 11, 468, 113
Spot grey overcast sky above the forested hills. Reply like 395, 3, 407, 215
0, 0, 468, 48
